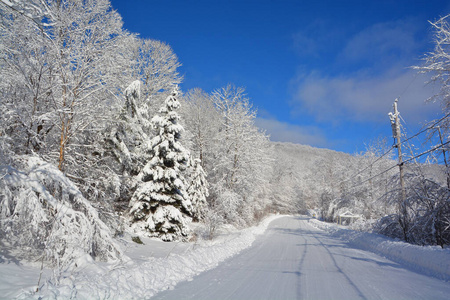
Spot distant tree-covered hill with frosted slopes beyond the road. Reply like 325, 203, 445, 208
272, 142, 446, 209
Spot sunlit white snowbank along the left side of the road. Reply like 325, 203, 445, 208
0, 215, 280, 299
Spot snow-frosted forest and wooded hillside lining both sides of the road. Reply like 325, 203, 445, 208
0, 0, 450, 286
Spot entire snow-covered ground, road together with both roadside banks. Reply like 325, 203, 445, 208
0, 216, 450, 299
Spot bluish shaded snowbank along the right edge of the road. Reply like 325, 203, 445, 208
309, 218, 450, 280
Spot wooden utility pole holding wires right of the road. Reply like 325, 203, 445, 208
389, 98, 407, 241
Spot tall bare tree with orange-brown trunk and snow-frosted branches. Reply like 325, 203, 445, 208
46, 0, 126, 170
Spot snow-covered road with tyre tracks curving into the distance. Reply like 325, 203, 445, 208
152, 217, 450, 299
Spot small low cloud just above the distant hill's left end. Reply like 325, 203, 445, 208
256, 117, 329, 147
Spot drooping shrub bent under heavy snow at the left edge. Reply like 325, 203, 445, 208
0, 157, 122, 267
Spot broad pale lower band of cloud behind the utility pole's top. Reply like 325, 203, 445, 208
292, 70, 439, 123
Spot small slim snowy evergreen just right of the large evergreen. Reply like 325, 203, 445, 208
187, 158, 209, 221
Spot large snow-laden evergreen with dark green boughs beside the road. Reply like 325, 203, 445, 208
130, 90, 192, 241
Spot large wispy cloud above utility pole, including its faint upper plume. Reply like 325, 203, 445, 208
292, 19, 440, 123
